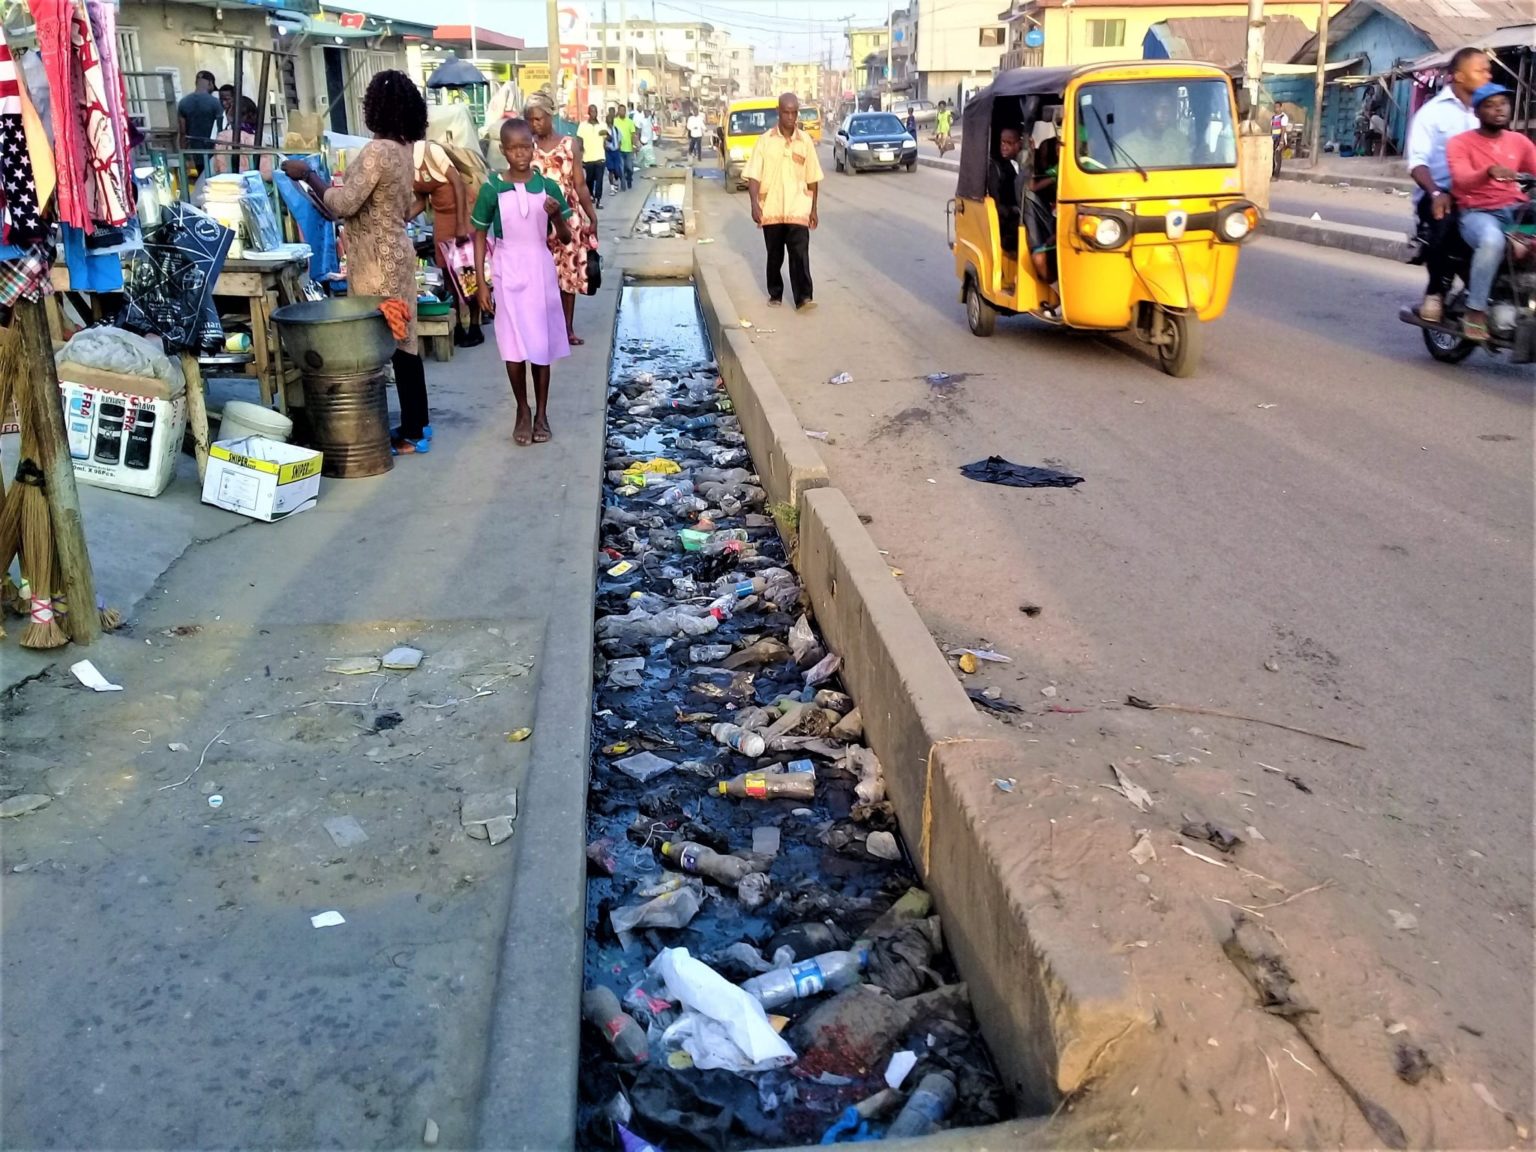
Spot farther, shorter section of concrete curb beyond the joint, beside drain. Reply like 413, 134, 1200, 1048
693, 264, 829, 508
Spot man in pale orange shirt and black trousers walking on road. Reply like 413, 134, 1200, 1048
742, 92, 822, 309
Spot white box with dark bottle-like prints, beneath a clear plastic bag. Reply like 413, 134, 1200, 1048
58, 364, 187, 496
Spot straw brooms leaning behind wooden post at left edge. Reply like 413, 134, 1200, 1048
0, 332, 123, 648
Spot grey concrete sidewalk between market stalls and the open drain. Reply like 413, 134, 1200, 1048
0, 221, 623, 1149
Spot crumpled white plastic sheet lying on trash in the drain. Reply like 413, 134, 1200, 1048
650, 948, 794, 1072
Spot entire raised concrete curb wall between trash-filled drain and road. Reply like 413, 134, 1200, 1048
696, 248, 1147, 1111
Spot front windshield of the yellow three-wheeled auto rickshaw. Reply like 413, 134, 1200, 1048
1074, 78, 1238, 174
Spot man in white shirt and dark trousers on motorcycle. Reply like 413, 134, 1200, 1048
1407, 48, 1493, 324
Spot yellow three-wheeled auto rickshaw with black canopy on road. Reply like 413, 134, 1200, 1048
948, 60, 1260, 376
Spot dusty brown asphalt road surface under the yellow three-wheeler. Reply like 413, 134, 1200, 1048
697, 149, 1536, 1107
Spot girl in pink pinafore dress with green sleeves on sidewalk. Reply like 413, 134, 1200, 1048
470, 120, 571, 445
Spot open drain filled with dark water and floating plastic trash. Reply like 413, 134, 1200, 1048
578, 283, 1012, 1152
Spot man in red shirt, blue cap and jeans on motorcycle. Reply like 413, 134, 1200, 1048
1445, 84, 1536, 339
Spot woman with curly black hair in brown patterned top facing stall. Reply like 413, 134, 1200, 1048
283, 69, 432, 456
